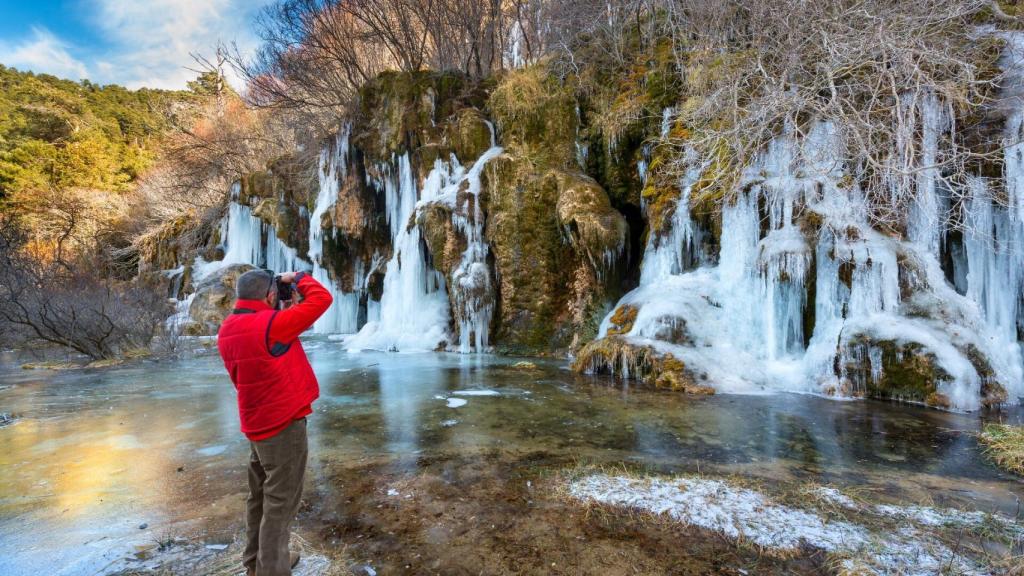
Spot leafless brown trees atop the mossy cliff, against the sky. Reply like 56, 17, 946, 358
231, 0, 520, 117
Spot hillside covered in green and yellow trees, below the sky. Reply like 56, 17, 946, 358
0, 66, 197, 205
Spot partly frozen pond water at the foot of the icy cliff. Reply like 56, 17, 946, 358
0, 340, 1024, 576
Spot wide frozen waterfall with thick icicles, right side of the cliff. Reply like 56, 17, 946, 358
585, 33, 1024, 410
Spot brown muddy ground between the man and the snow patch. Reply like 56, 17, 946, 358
300, 450, 829, 576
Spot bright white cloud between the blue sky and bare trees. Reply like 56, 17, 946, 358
91, 0, 267, 88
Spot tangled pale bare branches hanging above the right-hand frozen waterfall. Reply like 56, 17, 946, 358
660, 0, 999, 230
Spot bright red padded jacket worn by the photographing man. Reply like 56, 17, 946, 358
217, 273, 333, 441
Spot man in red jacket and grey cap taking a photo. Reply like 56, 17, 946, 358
217, 270, 332, 576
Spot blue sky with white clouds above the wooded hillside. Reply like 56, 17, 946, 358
0, 0, 271, 88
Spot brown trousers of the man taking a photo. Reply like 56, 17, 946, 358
242, 418, 309, 576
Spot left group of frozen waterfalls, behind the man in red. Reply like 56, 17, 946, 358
167, 112, 502, 353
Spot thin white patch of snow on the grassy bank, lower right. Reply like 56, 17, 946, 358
568, 475, 1019, 575
